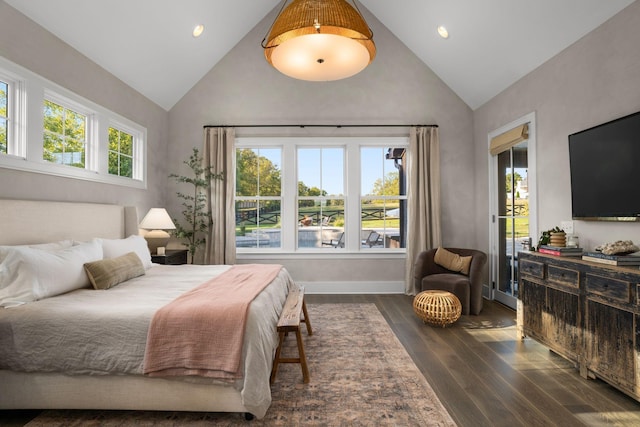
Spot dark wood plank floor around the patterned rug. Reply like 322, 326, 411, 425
0, 295, 640, 427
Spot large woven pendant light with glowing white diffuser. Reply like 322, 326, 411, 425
262, 0, 376, 81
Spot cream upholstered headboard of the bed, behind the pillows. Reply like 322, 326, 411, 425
0, 199, 138, 245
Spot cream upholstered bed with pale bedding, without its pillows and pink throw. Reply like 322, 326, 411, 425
0, 200, 295, 418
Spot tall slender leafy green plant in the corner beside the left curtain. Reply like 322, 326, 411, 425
169, 148, 222, 264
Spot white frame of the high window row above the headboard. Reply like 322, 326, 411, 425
0, 56, 147, 189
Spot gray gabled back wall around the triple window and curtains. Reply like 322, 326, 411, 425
168, 5, 476, 288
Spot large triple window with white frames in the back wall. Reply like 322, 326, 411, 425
235, 137, 407, 254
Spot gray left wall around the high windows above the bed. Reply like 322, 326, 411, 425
0, 1, 168, 215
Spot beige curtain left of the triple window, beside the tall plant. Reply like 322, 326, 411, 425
202, 128, 236, 264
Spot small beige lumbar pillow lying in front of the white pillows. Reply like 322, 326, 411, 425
84, 252, 145, 289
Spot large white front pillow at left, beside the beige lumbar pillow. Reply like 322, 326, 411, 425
0, 240, 102, 307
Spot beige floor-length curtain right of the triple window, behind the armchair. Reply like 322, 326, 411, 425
405, 127, 441, 295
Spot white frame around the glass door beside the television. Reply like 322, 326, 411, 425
483, 111, 538, 309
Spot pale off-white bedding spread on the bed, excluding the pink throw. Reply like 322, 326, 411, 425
0, 265, 295, 417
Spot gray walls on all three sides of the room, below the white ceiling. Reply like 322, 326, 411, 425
6, 1, 640, 290
